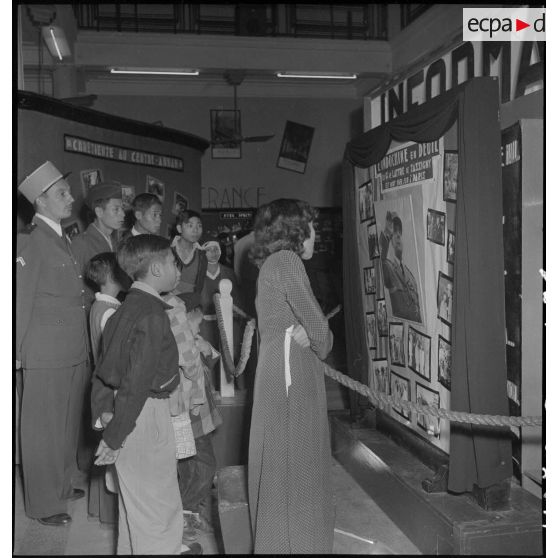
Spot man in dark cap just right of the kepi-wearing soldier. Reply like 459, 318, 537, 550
72, 182, 124, 308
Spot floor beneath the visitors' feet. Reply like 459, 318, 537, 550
13, 459, 420, 556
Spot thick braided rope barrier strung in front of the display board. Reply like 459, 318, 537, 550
213, 294, 543, 427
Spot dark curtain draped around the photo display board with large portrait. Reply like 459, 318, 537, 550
343, 78, 512, 492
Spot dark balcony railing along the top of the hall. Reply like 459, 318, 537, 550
74, 2, 388, 40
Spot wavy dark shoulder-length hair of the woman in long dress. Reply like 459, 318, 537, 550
250, 198, 317, 267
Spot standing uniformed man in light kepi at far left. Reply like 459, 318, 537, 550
16, 161, 88, 526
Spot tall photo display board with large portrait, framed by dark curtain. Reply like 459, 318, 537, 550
354, 133, 458, 452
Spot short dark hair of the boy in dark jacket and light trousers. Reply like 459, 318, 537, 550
116, 234, 171, 281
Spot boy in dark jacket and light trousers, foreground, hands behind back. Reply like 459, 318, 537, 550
92, 235, 199, 554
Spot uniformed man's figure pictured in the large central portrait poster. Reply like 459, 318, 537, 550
380, 211, 421, 322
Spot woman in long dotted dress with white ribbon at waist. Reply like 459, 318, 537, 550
248, 199, 334, 554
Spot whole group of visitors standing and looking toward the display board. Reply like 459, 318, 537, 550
16, 161, 340, 554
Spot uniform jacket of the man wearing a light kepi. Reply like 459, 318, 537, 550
16, 217, 88, 369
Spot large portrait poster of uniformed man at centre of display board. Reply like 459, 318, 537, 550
374, 196, 424, 324
